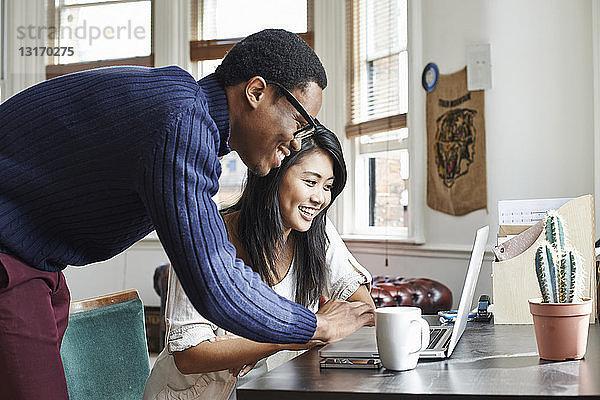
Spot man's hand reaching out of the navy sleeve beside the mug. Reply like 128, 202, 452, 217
312, 299, 375, 342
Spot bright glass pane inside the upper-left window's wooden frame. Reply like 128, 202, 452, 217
55, 0, 152, 64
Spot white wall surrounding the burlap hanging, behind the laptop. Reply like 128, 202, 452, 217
316, 0, 597, 303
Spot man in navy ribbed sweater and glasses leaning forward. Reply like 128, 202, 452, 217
0, 30, 373, 399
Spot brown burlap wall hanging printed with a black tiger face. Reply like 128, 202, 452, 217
427, 68, 487, 215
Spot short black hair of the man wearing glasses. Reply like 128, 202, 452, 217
215, 29, 327, 90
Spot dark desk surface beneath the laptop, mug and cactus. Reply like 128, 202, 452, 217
237, 323, 600, 400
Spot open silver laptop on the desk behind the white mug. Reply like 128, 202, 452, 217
319, 226, 490, 359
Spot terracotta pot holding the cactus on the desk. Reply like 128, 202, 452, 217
529, 298, 592, 361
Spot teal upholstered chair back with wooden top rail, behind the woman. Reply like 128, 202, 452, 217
61, 290, 150, 400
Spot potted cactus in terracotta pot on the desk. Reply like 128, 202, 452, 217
529, 211, 592, 360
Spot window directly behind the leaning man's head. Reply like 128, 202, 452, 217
190, 0, 313, 208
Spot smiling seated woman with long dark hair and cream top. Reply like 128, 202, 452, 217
144, 126, 374, 400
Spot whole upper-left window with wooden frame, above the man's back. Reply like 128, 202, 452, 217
44, 0, 153, 78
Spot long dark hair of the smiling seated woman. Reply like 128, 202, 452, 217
223, 125, 347, 307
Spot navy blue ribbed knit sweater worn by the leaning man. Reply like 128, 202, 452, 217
0, 67, 316, 343
